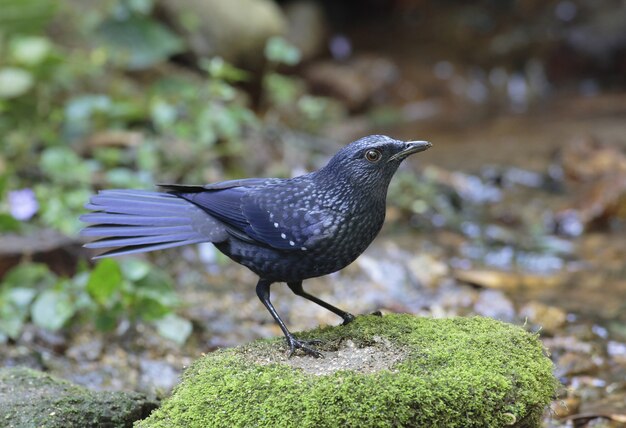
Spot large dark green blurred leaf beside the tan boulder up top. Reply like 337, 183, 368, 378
97, 14, 184, 70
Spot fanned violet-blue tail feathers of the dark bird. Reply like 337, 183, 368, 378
80, 190, 213, 258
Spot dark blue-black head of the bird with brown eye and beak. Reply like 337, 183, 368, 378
325, 135, 432, 194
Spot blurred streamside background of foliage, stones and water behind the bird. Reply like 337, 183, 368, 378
0, 0, 626, 427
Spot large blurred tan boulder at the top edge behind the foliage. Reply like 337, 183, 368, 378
156, 0, 287, 67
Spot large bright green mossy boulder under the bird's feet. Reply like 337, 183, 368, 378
137, 315, 558, 428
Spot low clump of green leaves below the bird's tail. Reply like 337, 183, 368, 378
0, 259, 191, 343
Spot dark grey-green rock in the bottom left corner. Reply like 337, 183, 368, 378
0, 367, 157, 428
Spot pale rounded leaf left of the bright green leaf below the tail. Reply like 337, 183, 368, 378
31, 286, 76, 331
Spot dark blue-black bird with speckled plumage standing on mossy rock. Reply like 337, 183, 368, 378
80, 135, 432, 357
